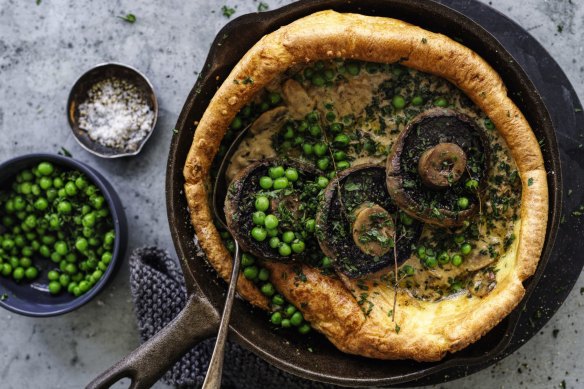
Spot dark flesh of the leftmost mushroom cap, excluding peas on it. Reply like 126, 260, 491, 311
224, 158, 321, 261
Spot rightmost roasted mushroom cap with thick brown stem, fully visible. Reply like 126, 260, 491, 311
387, 108, 489, 227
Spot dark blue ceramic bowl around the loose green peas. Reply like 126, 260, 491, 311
0, 154, 128, 317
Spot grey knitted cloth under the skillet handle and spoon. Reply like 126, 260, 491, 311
130, 247, 333, 389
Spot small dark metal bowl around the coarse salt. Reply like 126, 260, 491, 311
67, 62, 158, 158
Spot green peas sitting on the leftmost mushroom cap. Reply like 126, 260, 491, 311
250, 166, 318, 257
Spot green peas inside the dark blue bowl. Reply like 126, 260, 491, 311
0, 162, 115, 296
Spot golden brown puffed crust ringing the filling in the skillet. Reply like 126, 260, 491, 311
184, 11, 548, 361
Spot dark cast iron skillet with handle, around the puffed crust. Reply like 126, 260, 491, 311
88, 0, 582, 388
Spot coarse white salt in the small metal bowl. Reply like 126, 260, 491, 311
79, 77, 154, 151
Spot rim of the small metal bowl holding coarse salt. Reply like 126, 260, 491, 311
65, 61, 158, 159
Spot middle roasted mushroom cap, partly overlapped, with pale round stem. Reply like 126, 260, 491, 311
316, 165, 422, 278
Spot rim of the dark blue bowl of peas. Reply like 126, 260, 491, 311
0, 153, 127, 317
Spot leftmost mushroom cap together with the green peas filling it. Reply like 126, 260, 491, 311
224, 158, 320, 261
